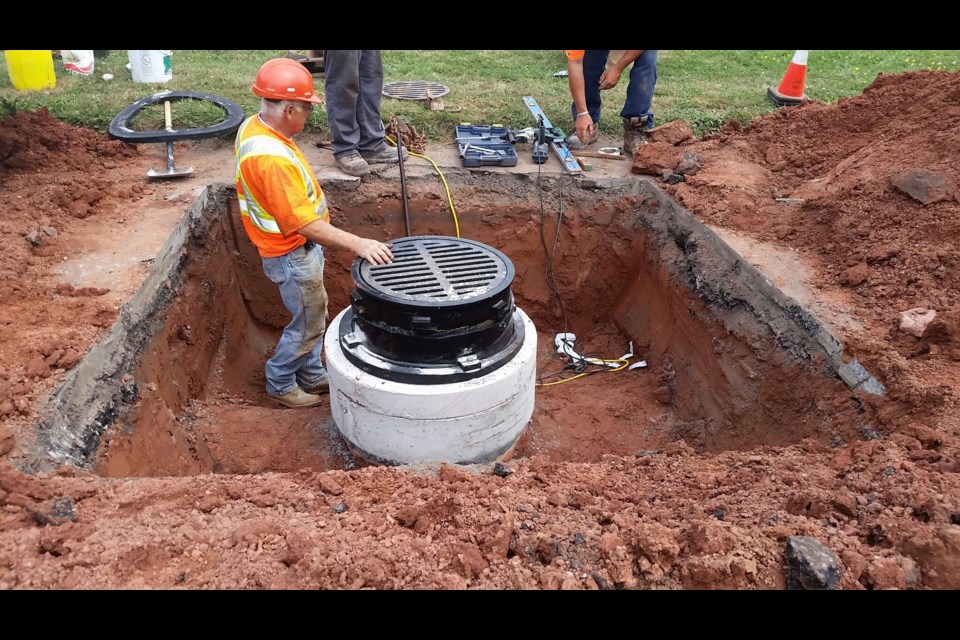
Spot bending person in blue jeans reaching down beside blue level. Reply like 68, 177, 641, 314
564, 49, 657, 155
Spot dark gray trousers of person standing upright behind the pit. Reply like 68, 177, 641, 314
323, 49, 386, 158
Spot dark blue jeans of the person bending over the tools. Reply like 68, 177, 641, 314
570, 49, 657, 129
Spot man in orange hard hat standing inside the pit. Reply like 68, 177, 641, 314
235, 58, 393, 408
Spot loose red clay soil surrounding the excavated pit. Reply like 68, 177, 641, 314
0, 72, 960, 590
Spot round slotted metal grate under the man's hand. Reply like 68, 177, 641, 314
358, 236, 514, 306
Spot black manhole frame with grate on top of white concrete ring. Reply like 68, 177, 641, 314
338, 235, 525, 384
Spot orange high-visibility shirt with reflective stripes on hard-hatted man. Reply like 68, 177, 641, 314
234, 114, 330, 258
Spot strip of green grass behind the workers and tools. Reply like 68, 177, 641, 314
0, 50, 960, 141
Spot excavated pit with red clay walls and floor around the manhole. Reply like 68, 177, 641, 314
22, 172, 884, 477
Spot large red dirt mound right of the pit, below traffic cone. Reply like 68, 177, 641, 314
663, 71, 960, 433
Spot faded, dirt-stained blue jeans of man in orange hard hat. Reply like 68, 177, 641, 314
261, 242, 327, 396
